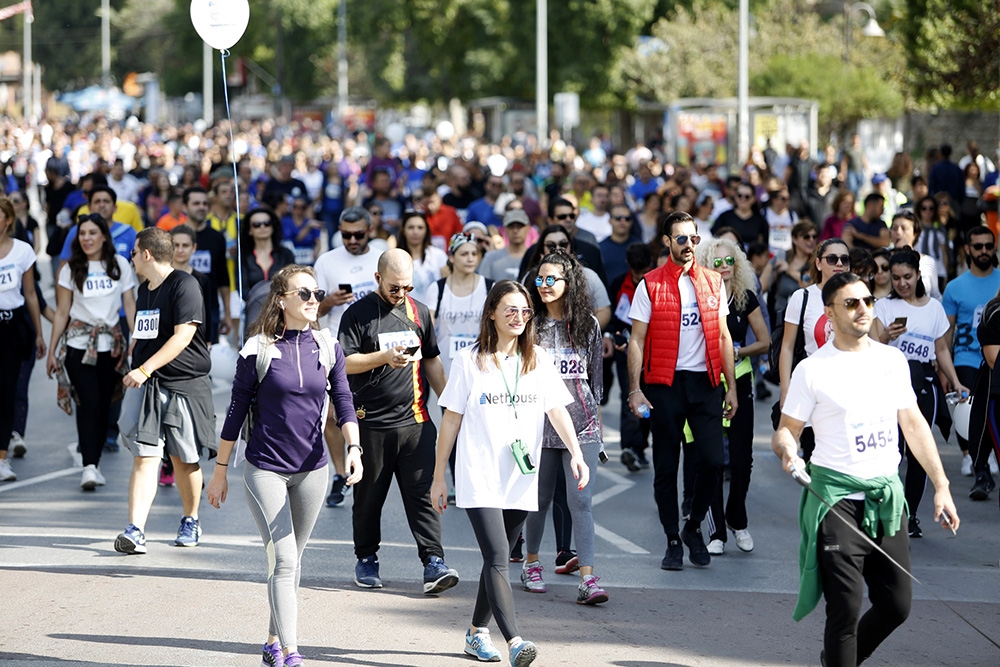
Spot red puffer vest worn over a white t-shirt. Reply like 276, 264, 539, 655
642, 260, 722, 387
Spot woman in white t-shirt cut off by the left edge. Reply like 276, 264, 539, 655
0, 197, 45, 482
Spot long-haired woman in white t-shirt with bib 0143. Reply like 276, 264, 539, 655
46, 214, 136, 491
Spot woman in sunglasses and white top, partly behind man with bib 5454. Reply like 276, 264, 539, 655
778, 239, 851, 461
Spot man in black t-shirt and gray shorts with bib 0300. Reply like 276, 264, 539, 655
115, 227, 217, 554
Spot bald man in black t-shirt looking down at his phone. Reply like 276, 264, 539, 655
340, 249, 458, 595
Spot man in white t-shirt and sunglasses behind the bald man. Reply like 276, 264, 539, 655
313, 206, 382, 507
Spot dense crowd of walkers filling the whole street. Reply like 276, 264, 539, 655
0, 116, 1000, 667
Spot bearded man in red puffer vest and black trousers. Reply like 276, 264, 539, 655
628, 212, 740, 570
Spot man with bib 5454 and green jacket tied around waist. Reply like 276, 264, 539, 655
771, 273, 959, 665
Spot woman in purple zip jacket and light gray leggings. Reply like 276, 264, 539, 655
207, 265, 362, 667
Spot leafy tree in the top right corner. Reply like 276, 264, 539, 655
902, 0, 1000, 108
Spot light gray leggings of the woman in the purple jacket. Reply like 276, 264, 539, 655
243, 461, 330, 648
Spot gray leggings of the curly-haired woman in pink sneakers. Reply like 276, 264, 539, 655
524, 442, 601, 567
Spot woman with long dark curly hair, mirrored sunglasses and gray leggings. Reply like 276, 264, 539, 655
521, 252, 608, 604
